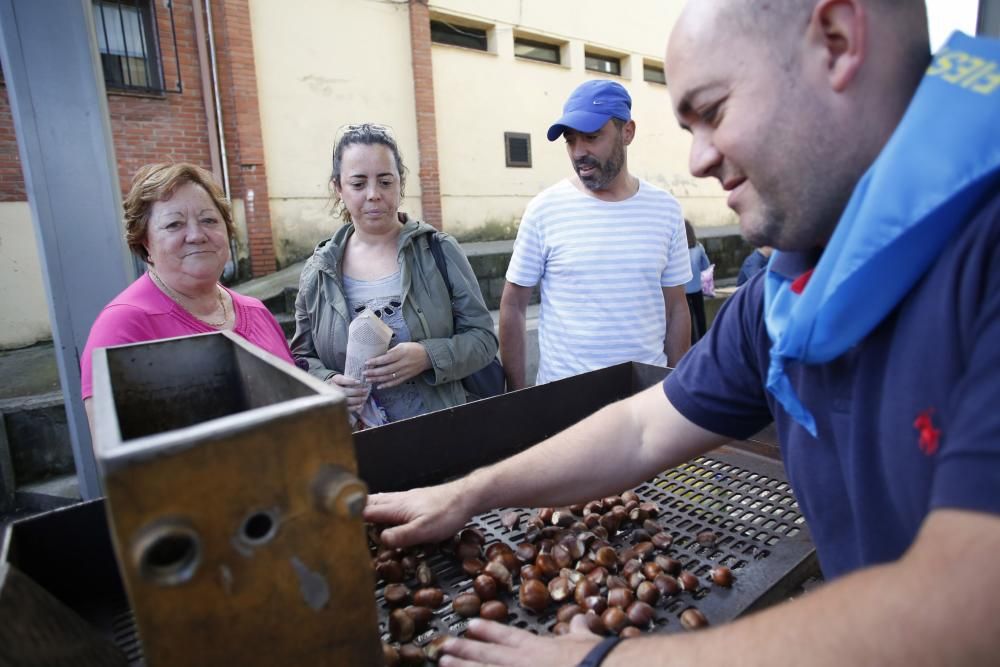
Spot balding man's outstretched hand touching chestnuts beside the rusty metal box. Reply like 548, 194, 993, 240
364, 480, 475, 548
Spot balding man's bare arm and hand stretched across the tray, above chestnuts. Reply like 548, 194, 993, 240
365, 385, 727, 546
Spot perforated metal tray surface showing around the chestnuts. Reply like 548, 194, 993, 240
376, 447, 818, 645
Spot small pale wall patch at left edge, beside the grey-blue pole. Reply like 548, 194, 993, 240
0, 202, 52, 350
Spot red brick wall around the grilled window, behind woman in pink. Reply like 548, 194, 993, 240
0, 0, 275, 277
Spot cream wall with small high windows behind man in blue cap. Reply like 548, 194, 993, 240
431, 0, 736, 235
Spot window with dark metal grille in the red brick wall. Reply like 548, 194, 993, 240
94, 0, 165, 93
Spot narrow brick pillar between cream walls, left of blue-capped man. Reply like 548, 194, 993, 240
410, 0, 442, 229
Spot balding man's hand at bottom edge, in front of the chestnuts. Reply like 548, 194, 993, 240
438, 614, 601, 667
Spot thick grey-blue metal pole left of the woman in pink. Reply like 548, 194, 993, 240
0, 0, 134, 498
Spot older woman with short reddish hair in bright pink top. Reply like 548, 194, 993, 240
80, 163, 294, 428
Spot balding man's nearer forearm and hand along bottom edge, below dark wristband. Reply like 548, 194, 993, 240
440, 510, 1000, 667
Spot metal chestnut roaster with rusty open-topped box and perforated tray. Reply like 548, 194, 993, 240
0, 334, 818, 665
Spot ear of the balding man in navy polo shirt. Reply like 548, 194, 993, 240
809, 0, 868, 93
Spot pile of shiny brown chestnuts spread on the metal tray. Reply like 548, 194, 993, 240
369, 491, 734, 665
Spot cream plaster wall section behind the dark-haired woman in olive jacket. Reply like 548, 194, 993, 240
250, 0, 420, 268
